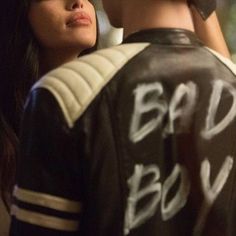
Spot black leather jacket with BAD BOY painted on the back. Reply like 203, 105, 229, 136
11, 29, 236, 236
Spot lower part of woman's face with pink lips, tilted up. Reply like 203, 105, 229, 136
29, 0, 97, 52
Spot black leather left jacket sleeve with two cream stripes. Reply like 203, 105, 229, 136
10, 88, 82, 236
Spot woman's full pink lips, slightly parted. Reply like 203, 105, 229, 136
66, 12, 92, 27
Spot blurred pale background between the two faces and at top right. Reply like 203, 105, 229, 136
94, 0, 236, 62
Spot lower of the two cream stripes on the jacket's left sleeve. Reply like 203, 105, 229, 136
11, 205, 79, 232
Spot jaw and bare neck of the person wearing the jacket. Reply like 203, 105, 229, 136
102, 0, 193, 37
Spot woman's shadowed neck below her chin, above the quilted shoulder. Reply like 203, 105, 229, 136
39, 49, 80, 77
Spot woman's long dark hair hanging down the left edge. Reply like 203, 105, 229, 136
0, 0, 96, 210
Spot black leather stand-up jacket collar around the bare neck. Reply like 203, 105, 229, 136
123, 28, 202, 46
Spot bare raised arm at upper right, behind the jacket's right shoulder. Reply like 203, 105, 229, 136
191, 7, 231, 58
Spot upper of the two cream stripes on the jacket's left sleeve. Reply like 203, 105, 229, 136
13, 186, 81, 213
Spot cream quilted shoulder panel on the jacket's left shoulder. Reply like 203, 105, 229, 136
32, 43, 149, 127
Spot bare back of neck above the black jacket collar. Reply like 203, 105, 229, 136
122, 0, 194, 37
